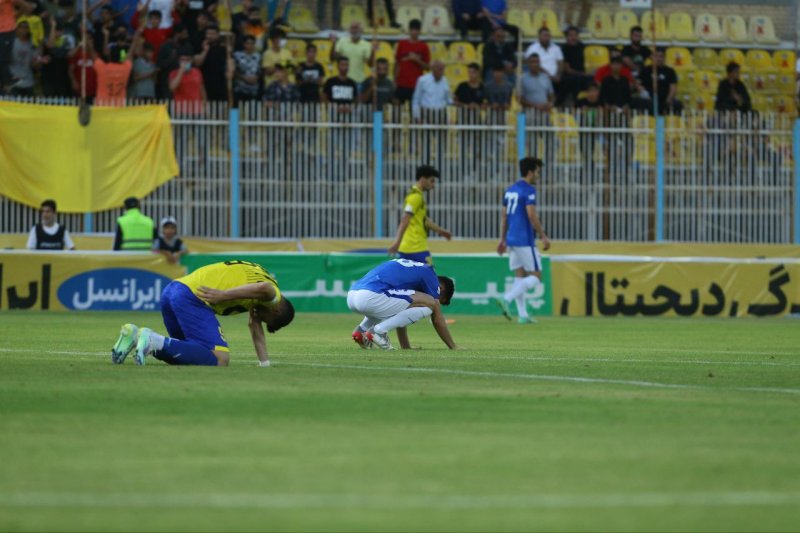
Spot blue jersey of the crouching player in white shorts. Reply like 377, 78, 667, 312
350, 259, 439, 301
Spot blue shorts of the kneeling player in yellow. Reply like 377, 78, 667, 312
161, 281, 228, 352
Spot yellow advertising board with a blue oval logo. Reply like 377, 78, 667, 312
0, 252, 185, 311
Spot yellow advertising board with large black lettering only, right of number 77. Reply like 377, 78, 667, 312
552, 256, 800, 317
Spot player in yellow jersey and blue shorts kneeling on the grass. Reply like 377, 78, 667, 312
111, 261, 294, 366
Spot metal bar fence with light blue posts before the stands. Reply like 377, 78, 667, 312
0, 101, 798, 243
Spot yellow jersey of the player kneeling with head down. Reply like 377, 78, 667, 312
176, 260, 281, 315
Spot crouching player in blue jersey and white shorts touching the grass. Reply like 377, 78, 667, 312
347, 259, 456, 350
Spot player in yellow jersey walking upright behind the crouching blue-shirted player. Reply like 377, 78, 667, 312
389, 165, 453, 266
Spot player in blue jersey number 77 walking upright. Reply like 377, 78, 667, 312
496, 157, 550, 324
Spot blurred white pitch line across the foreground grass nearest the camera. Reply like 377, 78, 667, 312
0, 491, 800, 510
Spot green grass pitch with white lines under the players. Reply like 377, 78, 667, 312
0, 312, 800, 531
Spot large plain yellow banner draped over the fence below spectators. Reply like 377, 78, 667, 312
0, 101, 179, 213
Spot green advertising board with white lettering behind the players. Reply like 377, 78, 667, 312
182, 252, 553, 316
